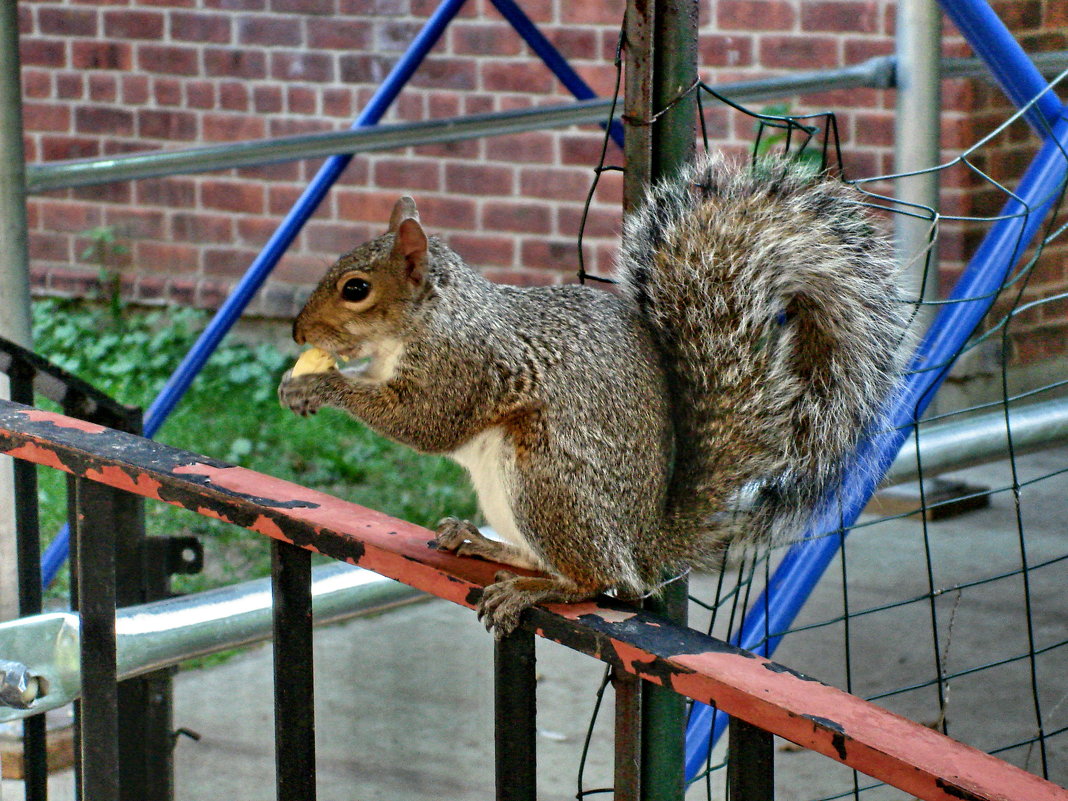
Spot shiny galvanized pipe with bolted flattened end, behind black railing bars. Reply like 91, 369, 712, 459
0, 563, 429, 723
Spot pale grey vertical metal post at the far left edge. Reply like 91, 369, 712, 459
0, 2, 31, 621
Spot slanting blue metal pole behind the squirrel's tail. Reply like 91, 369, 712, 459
686, 103, 1068, 781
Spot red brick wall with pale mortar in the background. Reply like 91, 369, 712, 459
19, 0, 1068, 363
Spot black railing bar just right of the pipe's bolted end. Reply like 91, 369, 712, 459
75, 478, 119, 801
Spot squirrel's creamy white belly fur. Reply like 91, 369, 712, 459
449, 428, 537, 561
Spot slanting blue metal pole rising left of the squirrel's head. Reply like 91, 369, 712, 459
41, 0, 465, 586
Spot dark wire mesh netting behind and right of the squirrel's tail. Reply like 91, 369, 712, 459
578, 26, 1068, 800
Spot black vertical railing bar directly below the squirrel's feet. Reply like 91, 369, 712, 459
493, 628, 537, 801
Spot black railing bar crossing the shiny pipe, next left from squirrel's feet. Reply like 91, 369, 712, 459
271, 539, 315, 801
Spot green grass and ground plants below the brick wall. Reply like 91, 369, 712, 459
34, 300, 475, 598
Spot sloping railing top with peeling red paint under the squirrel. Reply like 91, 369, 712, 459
0, 402, 1068, 801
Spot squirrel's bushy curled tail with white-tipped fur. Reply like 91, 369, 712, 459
622, 155, 910, 564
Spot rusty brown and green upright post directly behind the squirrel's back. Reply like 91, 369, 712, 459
616, 0, 697, 801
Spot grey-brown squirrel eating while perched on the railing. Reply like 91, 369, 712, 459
279, 155, 909, 637
